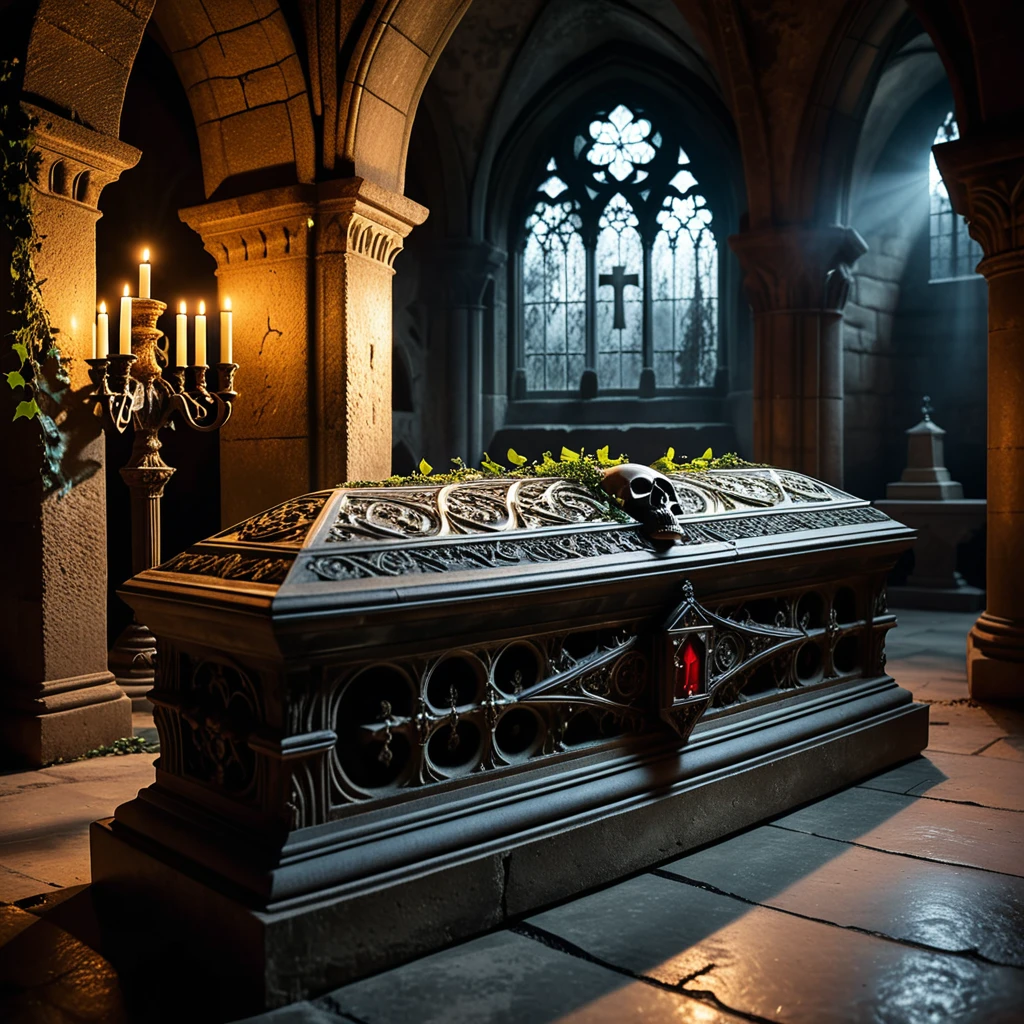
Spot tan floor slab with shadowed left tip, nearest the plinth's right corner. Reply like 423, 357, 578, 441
860, 753, 1024, 811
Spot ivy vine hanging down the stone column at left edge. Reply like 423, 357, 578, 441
0, 59, 74, 495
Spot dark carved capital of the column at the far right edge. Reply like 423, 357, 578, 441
932, 134, 1024, 278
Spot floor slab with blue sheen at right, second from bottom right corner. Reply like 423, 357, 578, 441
662, 826, 1024, 967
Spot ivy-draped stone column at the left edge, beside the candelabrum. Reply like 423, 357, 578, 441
0, 104, 139, 766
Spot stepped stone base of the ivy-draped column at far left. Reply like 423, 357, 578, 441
0, 672, 131, 768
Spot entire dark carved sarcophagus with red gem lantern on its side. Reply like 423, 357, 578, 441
93, 468, 927, 1008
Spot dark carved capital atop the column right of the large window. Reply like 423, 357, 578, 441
729, 224, 867, 313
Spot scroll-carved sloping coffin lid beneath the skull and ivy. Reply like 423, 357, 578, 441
132, 467, 908, 604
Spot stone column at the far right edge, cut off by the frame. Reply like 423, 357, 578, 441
933, 134, 1024, 700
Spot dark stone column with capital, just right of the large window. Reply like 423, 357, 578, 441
729, 226, 867, 486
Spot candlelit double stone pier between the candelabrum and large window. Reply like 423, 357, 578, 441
181, 178, 427, 525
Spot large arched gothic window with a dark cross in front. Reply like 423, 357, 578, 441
518, 102, 719, 393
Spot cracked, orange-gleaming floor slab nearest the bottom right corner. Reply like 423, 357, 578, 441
529, 874, 1024, 1024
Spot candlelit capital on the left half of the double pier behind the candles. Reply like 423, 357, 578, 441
178, 185, 316, 271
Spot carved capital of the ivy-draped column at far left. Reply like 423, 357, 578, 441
22, 103, 142, 213
